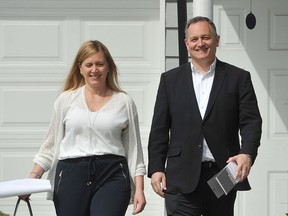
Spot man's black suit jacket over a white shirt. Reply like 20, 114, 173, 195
148, 59, 262, 193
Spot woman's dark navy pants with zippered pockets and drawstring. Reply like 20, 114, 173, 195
53, 155, 131, 216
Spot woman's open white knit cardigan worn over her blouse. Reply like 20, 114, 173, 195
33, 87, 146, 201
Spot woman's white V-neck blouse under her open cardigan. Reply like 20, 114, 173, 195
59, 88, 129, 160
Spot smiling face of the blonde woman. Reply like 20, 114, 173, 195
79, 51, 109, 87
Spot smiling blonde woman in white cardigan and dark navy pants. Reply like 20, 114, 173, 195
22, 41, 146, 216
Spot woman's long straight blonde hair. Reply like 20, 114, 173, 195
63, 40, 124, 92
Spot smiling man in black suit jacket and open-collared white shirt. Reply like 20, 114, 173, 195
148, 17, 262, 216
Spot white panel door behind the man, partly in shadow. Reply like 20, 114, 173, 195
214, 0, 288, 216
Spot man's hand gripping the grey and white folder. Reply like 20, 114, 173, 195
227, 154, 252, 182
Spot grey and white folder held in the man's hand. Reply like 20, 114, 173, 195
207, 162, 240, 198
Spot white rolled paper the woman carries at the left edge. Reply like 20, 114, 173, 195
0, 178, 51, 198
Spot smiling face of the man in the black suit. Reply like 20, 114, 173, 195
185, 21, 220, 64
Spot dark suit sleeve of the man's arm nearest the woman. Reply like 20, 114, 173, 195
148, 73, 171, 177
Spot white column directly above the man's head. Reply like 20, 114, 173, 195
193, 0, 213, 20
